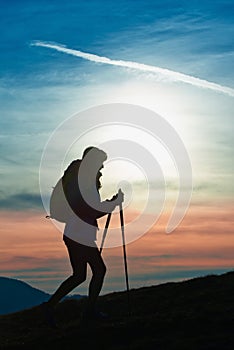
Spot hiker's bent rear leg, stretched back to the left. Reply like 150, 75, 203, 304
47, 237, 87, 306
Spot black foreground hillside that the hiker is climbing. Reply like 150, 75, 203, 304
0, 272, 234, 350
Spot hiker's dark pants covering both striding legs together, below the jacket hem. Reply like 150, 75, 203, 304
48, 236, 106, 308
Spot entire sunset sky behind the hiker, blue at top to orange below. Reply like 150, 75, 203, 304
0, 0, 234, 294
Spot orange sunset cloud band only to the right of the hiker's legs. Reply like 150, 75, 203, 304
102, 205, 234, 288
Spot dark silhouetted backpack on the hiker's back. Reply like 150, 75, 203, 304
47, 159, 80, 223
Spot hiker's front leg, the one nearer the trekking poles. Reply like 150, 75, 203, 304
88, 247, 106, 310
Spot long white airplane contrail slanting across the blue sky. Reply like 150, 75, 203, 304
31, 41, 234, 97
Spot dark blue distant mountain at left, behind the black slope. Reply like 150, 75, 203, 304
0, 277, 81, 315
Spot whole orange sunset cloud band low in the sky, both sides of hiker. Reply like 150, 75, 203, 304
0, 203, 234, 292
